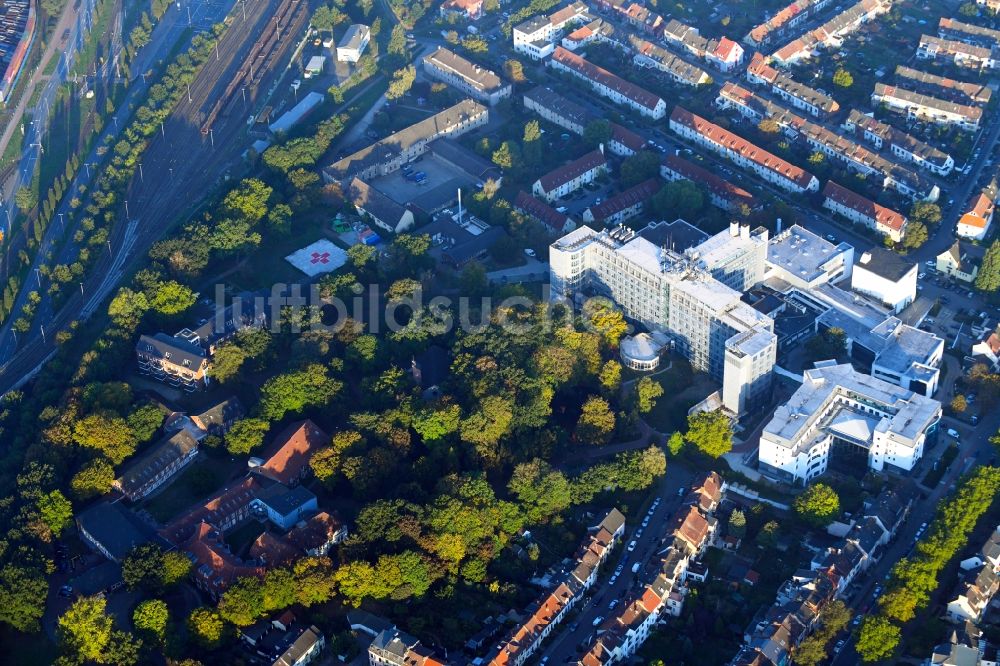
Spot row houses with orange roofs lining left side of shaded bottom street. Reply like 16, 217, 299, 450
484, 509, 625, 666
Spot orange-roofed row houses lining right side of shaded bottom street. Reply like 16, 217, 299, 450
575, 472, 726, 666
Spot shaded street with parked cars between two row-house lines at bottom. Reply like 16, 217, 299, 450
538, 464, 695, 664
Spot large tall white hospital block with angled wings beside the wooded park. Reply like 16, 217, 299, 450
549, 224, 777, 414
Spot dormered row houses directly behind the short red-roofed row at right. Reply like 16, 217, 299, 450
802, 122, 941, 201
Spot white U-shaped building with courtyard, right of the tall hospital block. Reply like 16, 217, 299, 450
758, 362, 941, 483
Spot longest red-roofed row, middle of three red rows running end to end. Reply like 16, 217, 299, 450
670, 106, 819, 193
